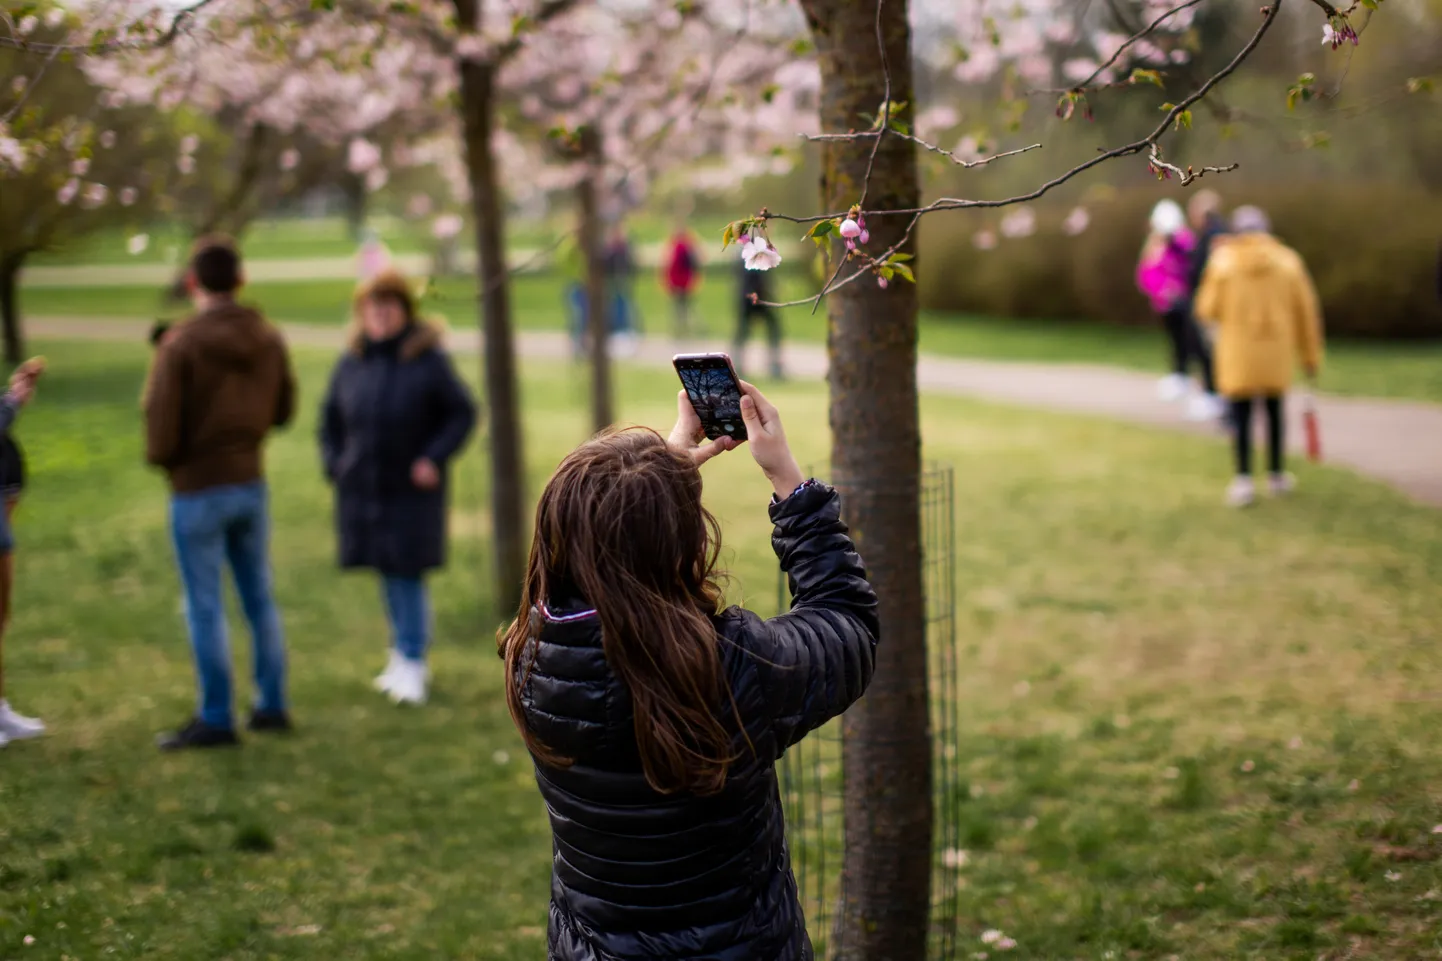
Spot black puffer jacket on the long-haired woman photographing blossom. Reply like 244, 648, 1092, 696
519, 483, 878, 961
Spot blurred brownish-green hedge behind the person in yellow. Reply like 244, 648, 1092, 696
917, 177, 1442, 339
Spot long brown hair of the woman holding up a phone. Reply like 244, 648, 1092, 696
499, 427, 735, 795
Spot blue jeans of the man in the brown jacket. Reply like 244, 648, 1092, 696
170, 481, 286, 727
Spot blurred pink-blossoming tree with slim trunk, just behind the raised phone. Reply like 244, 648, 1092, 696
508, 0, 818, 430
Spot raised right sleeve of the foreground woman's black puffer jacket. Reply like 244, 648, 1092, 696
747, 483, 880, 755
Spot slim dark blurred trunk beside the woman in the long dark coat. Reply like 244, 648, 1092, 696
457, 54, 525, 615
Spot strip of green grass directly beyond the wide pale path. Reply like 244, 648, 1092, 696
22, 271, 1442, 403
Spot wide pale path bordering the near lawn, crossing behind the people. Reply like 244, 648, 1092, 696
22, 317, 1442, 506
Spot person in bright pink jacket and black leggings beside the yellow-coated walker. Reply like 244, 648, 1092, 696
1136, 199, 1221, 420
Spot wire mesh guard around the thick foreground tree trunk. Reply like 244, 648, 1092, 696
777, 463, 962, 961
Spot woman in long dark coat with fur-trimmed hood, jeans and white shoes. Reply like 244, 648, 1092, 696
320, 271, 476, 704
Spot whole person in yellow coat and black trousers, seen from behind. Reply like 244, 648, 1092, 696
1197, 206, 1322, 506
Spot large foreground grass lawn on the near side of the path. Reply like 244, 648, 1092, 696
0, 343, 1442, 961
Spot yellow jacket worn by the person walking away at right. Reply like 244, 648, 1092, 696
1195, 234, 1322, 398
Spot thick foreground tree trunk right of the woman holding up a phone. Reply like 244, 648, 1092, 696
802, 0, 933, 961
